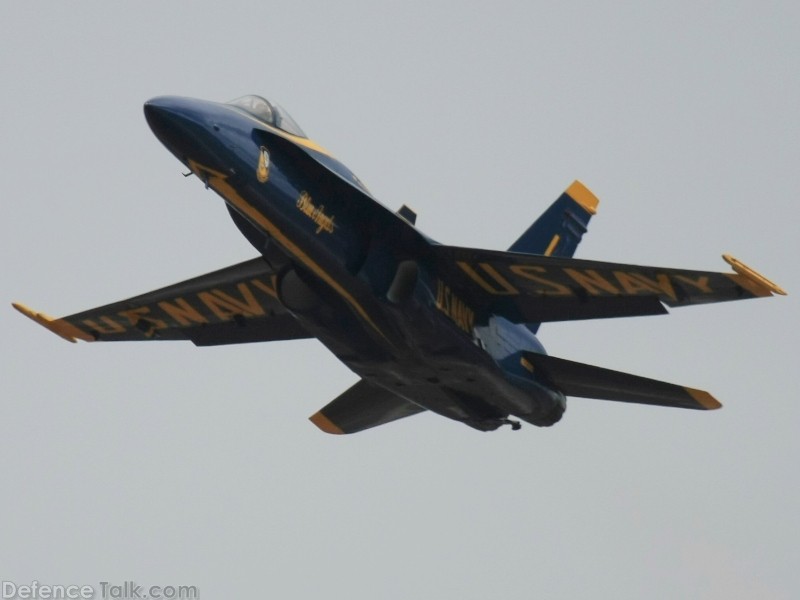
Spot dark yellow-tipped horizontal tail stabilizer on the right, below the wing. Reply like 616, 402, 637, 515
522, 352, 722, 410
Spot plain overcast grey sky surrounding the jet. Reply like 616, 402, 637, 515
0, 0, 800, 600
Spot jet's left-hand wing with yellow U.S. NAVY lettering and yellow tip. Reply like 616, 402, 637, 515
14, 258, 312, 346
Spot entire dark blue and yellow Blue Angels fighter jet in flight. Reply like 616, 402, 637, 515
14, 96, 785, 434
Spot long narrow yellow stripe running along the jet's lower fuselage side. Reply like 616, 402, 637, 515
189, 159, 390, 341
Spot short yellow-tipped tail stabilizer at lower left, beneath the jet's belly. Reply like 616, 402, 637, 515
310, 379, 425, 434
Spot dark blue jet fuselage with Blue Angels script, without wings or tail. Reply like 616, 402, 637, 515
145, 97, 566, 430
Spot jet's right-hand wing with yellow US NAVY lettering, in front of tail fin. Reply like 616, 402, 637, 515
432, 246, 786, 323
